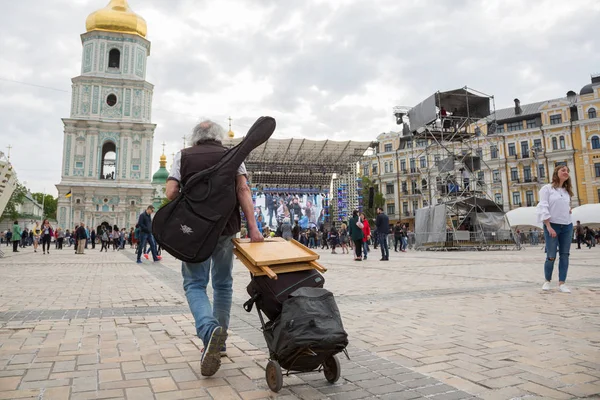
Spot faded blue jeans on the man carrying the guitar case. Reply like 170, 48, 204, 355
181, 236, 234, 347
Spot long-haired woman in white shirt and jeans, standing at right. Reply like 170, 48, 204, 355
537, 165, 573, 293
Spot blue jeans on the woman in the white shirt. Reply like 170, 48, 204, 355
544, 223, 573, 282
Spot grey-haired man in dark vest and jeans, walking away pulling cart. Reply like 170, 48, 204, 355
166, 121, 264, 376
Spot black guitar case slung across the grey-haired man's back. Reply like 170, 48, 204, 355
152, 117, 275, 263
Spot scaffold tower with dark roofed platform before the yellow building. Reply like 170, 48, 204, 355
394, 87, 516, 250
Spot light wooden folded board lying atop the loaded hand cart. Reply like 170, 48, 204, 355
233, 238, 319, 267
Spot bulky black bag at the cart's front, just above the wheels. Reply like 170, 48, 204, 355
273, 288, 348, 369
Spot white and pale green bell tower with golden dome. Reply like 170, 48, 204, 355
56, 0, 156, 229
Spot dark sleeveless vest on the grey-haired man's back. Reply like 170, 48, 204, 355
180, 141, 242, 236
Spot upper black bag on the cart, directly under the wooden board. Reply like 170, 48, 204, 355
244, 269, 325, 321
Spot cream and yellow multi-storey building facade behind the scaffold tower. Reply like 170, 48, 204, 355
360, 76, 600, 227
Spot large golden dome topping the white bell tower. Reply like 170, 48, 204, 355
85, 0, 148, 38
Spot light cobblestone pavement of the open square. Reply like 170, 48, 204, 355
0, 242, 600, 400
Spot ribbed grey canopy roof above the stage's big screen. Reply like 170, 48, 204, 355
224, 138, 372, 192
